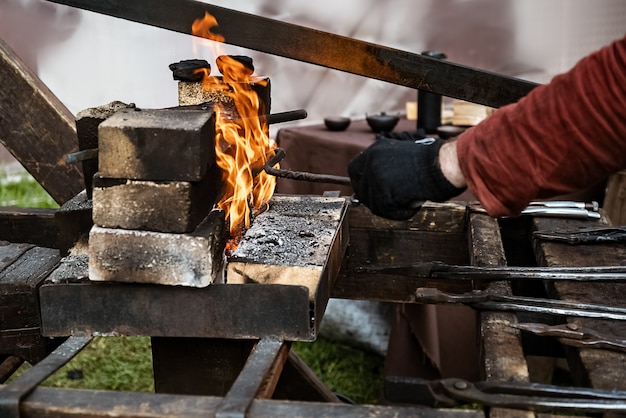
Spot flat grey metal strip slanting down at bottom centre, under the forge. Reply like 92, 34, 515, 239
215, 337, 289, 418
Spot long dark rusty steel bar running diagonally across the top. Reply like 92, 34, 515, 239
45, 0, 537, 107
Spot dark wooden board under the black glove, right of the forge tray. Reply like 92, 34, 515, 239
332, 202, 471, 303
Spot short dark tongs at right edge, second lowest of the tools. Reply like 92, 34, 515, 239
510, 322, 626, 352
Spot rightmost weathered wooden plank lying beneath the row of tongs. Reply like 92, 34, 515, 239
534, 214, 626, 390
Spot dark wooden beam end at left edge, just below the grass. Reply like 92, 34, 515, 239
0, 207, 59, 248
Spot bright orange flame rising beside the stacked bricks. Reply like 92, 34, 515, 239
193, 13, 276, 246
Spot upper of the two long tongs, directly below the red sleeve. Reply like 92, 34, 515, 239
359, 262, 626, 283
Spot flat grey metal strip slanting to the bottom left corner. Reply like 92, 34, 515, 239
0, 336, 91, 418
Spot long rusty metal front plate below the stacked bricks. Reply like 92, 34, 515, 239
40, 274, 314, 341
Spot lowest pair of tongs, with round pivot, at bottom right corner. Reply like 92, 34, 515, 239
384, 377, 626, 413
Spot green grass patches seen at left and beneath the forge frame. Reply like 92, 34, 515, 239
0, 166, 383, 404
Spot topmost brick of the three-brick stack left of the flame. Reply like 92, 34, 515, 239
98, 109, 215, 181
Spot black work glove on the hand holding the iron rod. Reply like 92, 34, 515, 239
348, 138, 465, 220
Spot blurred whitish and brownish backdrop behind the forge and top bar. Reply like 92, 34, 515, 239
0, 0, 626, 160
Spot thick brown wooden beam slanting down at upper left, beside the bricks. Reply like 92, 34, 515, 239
0, 39, 85, 204
